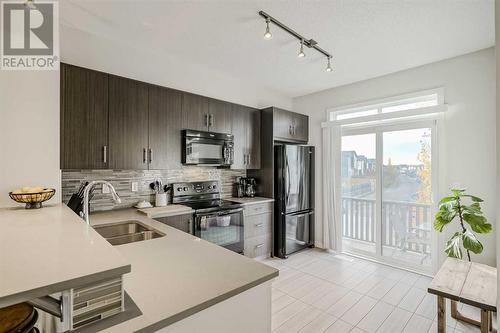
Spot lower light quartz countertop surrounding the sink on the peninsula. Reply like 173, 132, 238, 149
90, 209, 278, 332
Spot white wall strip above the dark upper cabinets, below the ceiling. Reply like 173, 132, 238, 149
60, 25, 292, 109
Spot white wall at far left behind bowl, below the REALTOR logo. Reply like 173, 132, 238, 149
0, 71, 61, 207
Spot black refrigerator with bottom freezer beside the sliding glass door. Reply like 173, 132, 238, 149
273, 144, 314, 258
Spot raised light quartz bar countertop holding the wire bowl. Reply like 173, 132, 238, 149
0, 204, 130, 308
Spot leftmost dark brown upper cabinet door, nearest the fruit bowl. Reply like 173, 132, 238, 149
60, 64, 108, 169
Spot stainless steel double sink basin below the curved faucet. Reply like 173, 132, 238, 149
94, 221, 165, 245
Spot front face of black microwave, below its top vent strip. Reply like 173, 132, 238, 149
182, 136, 232, 165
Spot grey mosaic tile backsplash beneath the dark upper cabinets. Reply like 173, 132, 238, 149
62, 167, 246, 211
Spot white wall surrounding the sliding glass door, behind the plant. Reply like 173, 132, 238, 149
293, 48, 496, 265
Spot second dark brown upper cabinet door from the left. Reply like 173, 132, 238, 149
109, 75, 150, 169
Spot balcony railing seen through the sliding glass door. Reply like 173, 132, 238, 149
342, 197, 431, 255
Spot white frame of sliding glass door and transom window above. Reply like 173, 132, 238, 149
322, 88, 447, 275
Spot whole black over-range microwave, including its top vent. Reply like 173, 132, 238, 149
182, 130, 234, 166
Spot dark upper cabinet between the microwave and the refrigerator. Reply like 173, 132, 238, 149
231, 104, 260, 169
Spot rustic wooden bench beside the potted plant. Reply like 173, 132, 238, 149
427, 258, 497, 333
